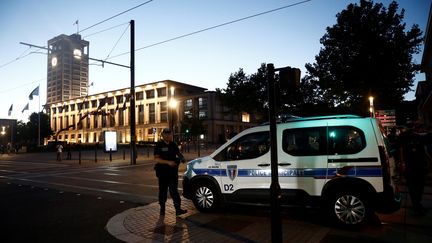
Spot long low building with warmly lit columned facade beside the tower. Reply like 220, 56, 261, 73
49, 80, 254, 143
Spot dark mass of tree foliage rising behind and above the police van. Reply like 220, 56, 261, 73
217, 0, 422, 118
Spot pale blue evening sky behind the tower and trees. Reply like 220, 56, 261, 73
0, 0, 431, 120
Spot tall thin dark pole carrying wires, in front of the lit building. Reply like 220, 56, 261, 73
130, 20, 136, 165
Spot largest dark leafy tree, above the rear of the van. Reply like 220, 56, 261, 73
302, 0, 422, 114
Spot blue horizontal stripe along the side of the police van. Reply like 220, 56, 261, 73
193, 166, 382, 178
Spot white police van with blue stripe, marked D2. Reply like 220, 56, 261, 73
183, 115, 400, 226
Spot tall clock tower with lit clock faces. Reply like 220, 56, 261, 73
47, 34, 89, 104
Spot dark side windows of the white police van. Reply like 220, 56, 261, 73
214, 126, 366, 161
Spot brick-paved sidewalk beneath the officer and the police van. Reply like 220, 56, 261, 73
106, 176, 432, 243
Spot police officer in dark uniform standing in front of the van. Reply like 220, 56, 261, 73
154, 128, 187, 215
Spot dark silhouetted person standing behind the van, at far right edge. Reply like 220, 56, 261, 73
399, 124, 427, 215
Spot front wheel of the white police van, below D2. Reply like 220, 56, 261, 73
192, 182, 220, 212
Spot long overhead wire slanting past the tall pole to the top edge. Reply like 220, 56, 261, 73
109, 0, 312, 59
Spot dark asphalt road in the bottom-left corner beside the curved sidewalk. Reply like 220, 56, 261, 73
0, 180, 141, 243
